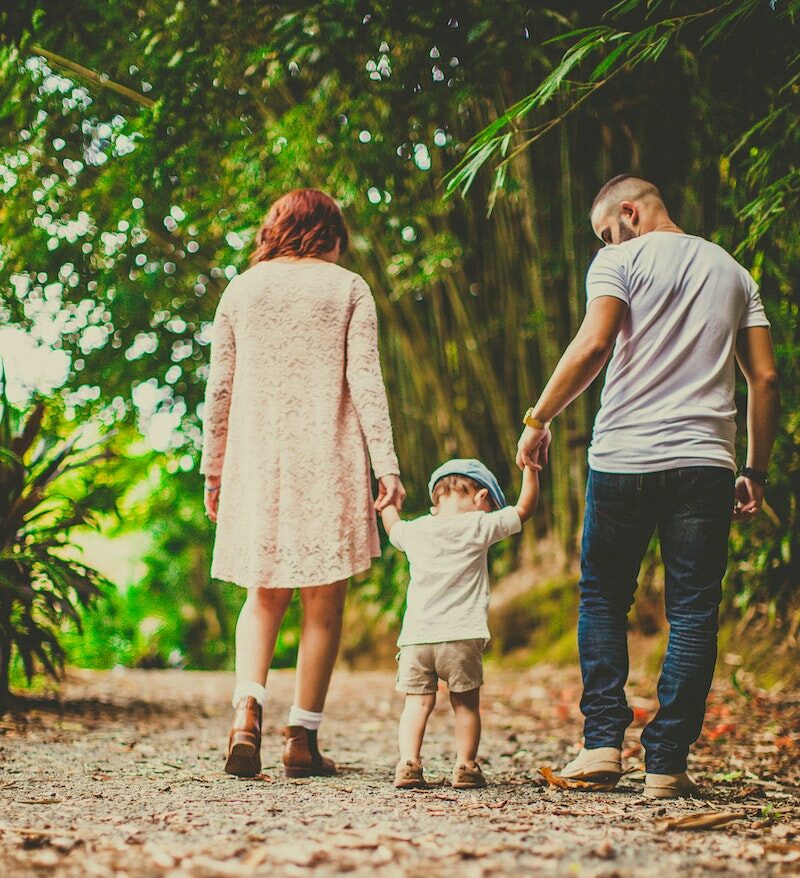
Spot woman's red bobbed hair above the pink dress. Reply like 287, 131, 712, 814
250, 189, 348, 265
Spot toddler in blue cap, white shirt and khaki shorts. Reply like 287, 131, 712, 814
381, 460, 541, 790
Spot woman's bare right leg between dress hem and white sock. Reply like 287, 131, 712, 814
294, 579, 347, 713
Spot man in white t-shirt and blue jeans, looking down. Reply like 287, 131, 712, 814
517, 174, 779, 798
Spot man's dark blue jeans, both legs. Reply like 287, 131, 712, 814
578, 466, 734, 774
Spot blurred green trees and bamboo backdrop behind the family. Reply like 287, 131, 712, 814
0, 0, 800, 680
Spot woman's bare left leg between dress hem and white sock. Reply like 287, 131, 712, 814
236, 588, 292, 686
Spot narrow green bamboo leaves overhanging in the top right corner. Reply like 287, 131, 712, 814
447, 0, 800, 247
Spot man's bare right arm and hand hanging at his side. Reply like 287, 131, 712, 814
734, 326, 780, 519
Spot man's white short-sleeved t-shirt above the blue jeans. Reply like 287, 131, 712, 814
586, 232, 769, 473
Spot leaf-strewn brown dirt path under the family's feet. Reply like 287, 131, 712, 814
0, 667, 800, 878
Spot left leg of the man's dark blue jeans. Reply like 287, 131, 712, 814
578, 470, 656, 749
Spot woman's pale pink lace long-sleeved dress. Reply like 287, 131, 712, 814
200, 259, 399, 588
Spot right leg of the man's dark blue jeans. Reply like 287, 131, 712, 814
642, 467, 734, 774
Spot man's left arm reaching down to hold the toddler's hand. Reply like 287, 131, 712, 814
517, 296, 628, 468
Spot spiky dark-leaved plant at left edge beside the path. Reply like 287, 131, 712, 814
0, 372, 113, 712
